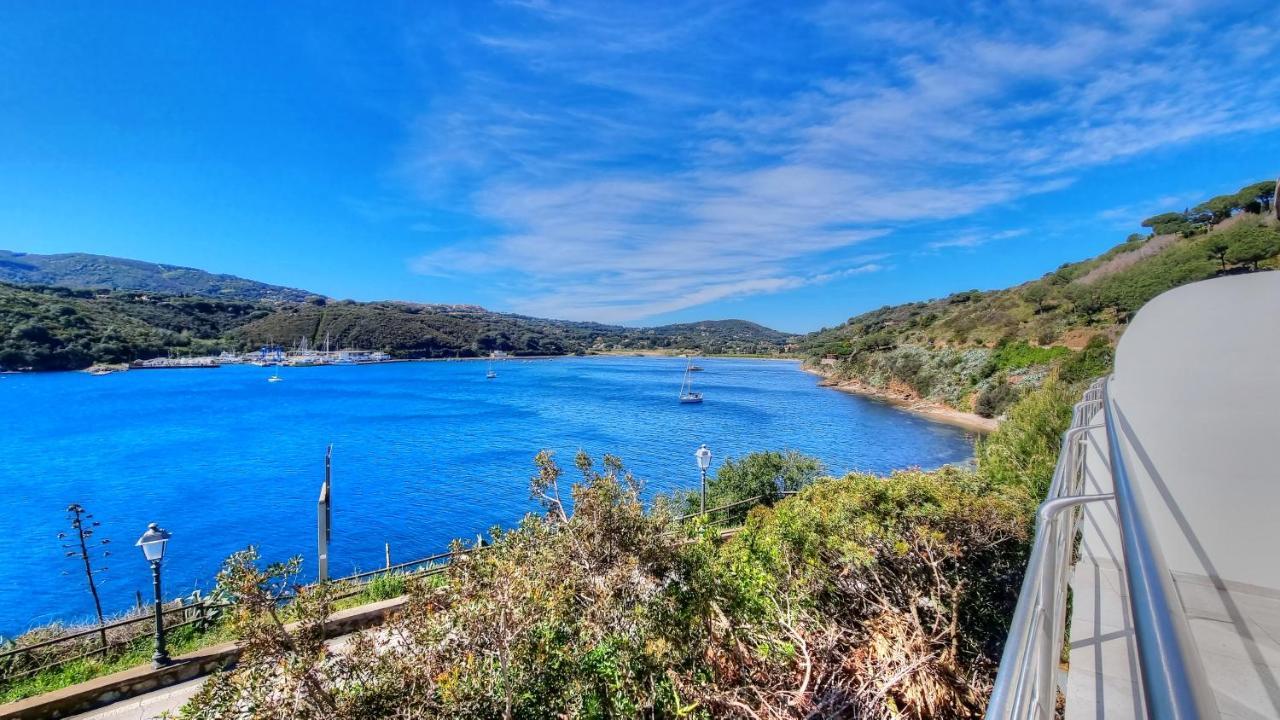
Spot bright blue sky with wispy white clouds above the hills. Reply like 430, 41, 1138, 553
0, 0, 1280, 331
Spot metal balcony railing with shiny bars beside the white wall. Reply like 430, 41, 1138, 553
986, 379, 1219, 720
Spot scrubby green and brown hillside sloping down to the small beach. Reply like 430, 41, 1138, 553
801, 175, 1280, 416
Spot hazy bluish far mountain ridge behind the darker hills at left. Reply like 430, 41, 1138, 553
0, 250, 311, 302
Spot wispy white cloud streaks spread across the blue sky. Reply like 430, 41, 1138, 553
401, 0, 1280, 320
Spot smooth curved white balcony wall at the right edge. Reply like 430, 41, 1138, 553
1111, 272, 1280, 589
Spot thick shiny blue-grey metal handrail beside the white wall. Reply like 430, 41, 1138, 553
1102, 380, 1219, 720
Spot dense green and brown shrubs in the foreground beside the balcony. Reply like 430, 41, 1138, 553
165, 382, 1080, 720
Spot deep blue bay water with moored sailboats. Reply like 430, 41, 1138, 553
0, 357, 973, 635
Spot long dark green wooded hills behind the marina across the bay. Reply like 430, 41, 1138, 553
0, 283, 792, 370
